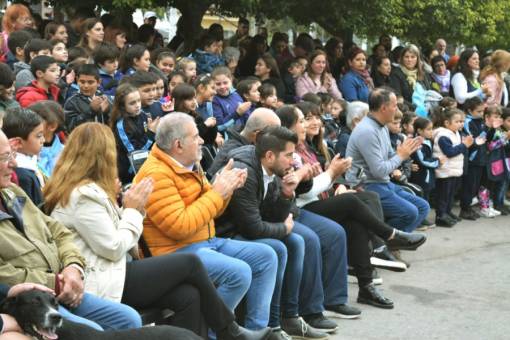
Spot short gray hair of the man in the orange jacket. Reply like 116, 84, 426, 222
156, 112, 195, 152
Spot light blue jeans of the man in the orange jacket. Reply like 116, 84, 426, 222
178, 237, 278, 329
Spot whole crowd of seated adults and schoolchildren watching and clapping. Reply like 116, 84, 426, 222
0, 4, 510, 340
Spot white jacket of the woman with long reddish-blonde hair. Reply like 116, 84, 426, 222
51, 183, 143, 302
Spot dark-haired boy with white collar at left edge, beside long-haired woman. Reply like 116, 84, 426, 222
2, 108, 45, 206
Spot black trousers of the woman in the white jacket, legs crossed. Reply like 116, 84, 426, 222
122, 254, 234, 335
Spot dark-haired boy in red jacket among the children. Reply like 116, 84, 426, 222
16, 56, 60, 107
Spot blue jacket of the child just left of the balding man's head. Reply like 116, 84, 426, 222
213, 88, 244, 133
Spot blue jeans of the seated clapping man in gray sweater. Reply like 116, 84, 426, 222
365, 182, 430, 233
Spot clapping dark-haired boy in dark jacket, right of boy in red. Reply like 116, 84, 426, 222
64, 64, 110, 133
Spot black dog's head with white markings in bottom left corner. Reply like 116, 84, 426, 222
0, 290, 62, 340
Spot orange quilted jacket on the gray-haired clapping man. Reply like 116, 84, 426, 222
133, 145, 228, 256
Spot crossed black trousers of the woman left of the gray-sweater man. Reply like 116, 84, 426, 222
303, 193, 393, 286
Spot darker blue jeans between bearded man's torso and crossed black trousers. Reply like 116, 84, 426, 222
293, 209, 347, 315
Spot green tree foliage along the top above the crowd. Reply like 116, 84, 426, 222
55, 0, 510, 48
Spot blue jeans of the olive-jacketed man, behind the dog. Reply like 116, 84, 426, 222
58, 293, 142, 330
